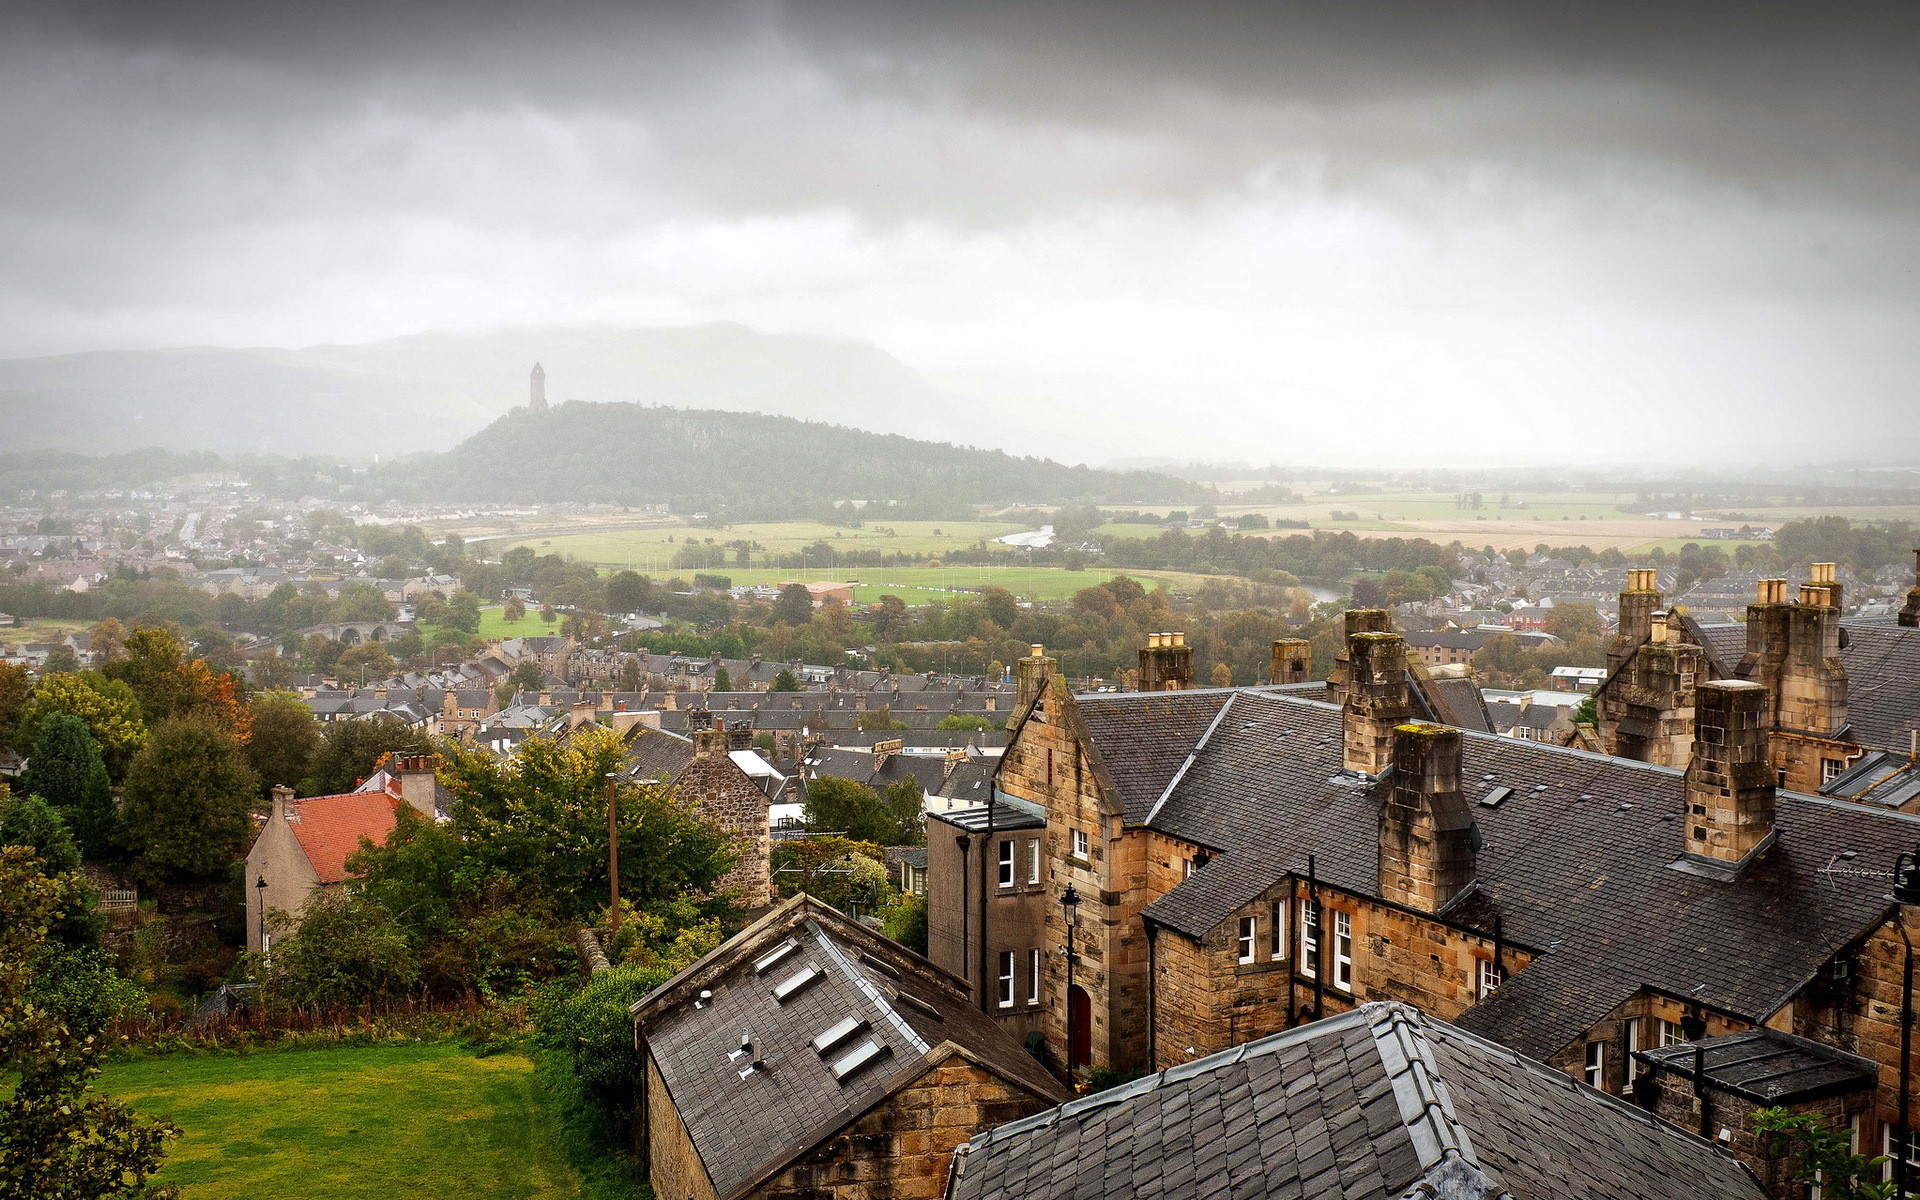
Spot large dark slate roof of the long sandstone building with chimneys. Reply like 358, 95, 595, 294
1144, 691, 1920, 1058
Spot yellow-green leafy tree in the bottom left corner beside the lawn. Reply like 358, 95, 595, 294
0, 845, 179, 1200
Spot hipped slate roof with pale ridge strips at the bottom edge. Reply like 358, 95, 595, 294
947, 1004, 1766, 1200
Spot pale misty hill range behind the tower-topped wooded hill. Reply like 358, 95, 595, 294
0, 324, 962, 459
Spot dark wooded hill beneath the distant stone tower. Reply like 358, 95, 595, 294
369, 401, 1200, 513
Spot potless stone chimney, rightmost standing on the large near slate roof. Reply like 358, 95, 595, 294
1684, 680, 1774, 866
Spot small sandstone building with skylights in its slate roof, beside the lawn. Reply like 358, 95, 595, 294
632, 897, 1068, 1200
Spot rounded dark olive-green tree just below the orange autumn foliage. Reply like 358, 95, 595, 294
121, 714, 259, 883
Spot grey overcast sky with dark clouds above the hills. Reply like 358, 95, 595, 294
0, 0, 1920, 463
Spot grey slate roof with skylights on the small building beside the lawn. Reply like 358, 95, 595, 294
632, 895, 1068, 1200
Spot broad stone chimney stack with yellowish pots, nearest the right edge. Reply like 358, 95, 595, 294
1736, 563, 1847, 748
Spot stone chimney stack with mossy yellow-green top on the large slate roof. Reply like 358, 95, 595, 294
1380, 722, 1475, 912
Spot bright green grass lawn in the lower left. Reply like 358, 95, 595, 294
100, 1044, 582, 1200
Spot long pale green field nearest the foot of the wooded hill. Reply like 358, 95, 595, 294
503, 520, 1027, 574
